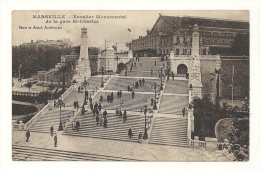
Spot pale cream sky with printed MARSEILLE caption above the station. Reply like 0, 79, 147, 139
12, 10, 249, 51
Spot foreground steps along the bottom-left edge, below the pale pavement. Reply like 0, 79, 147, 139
12, 145, 139, 161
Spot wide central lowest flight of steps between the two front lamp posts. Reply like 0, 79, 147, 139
63, 113, 144, 142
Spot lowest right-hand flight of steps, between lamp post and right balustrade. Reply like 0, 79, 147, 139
150, 117, 188, 147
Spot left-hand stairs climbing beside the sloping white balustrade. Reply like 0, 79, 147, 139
30, 90, 84, 133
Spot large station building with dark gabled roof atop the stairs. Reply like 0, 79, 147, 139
130, 15, 249, 56
